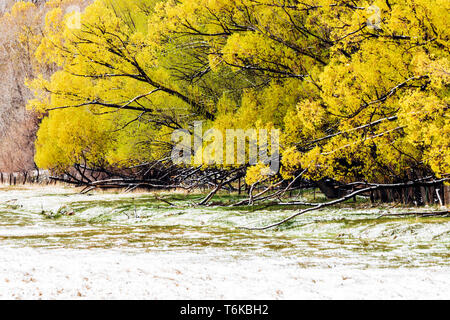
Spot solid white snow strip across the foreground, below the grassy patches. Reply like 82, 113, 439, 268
0, 249, 450, 299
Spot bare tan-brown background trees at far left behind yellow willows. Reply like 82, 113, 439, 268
0, 0, 89, 172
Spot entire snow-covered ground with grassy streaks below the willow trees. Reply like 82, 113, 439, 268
0, 185, 450, 299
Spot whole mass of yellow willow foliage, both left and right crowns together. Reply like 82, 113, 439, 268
29, 0, 450, 189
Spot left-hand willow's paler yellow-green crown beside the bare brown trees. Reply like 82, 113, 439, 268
29, 0, 255, 171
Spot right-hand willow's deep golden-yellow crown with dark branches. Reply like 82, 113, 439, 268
150, 0, 450, 182
